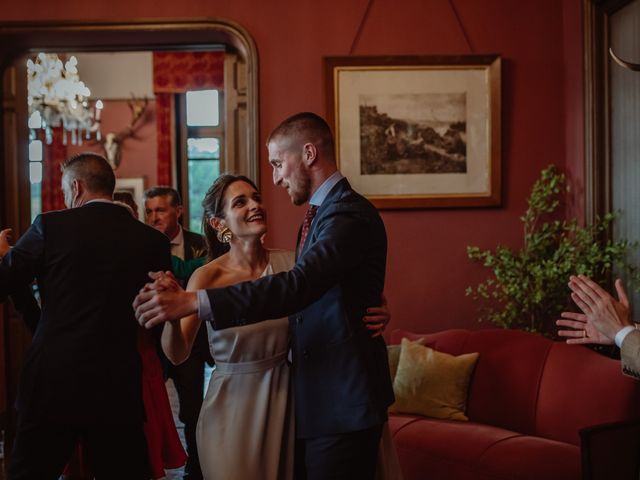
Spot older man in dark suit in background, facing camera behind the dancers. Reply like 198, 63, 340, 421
144, 186, 213, 480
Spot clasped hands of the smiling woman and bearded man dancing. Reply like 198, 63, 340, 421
133, 272, 198, 328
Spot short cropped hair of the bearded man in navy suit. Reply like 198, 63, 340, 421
267, 112, 334, 154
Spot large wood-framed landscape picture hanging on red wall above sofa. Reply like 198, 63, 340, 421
325, 55, 501, 208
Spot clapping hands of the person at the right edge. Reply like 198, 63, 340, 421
556, 275, 632, 345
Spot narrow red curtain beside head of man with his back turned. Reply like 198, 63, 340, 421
42, 127, 67, 213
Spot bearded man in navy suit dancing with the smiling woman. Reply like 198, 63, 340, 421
134, 113, 393, 479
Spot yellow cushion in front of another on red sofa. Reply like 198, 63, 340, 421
390, 338, 478, 421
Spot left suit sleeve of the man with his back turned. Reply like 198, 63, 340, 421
0, 215, 44, 297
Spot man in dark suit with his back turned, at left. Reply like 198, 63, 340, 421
0, 153, 171, 480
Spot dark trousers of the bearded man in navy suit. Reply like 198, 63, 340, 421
295, 425, 382, 480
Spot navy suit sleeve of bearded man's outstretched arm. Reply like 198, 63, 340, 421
207, 206, 386, 329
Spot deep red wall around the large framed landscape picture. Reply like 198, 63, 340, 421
0, 0, 582, 331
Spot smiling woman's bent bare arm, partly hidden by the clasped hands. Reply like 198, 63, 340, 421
161, 269, 205, 365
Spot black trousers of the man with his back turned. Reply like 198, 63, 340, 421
8, 418, 150, 480
